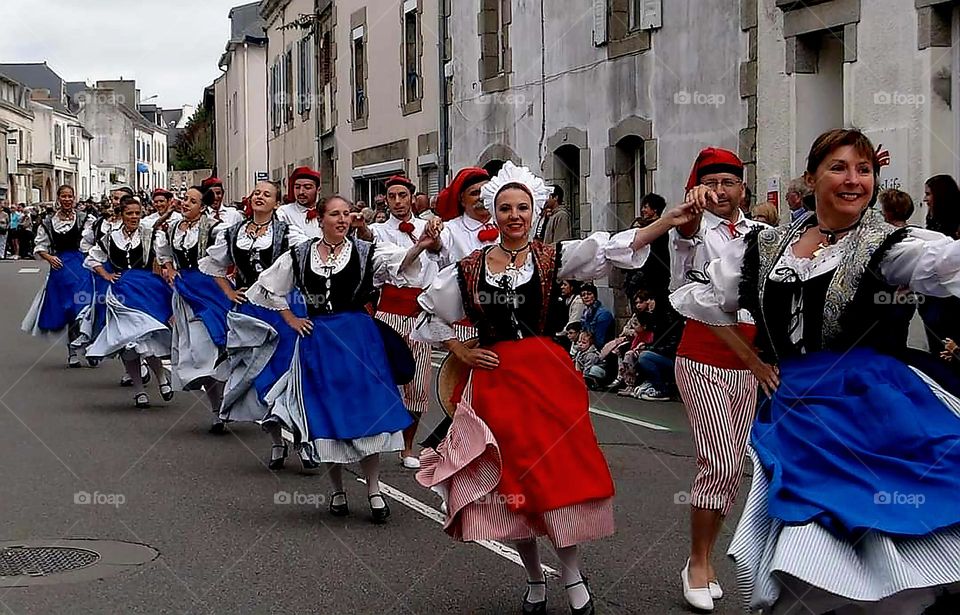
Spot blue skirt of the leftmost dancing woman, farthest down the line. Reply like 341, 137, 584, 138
37, 251, 93, 332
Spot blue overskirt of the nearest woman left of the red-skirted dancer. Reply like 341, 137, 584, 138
298, 312, 413, 440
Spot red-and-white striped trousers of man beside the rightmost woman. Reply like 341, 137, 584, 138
675, 357, 757, 515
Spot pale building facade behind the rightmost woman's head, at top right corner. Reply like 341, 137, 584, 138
752, 0, 960, 221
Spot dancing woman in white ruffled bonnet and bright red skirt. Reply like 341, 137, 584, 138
416, 162, 689, 614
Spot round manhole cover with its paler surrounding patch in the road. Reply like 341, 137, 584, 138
0, 538, 160, 588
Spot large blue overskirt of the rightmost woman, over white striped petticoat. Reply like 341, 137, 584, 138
751, 348, 960, 538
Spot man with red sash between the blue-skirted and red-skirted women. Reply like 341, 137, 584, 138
370, 175, 440, 470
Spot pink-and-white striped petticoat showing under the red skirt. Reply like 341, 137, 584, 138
417, 403, 614, 548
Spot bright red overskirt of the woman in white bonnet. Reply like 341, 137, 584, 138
473, 338, 614, 514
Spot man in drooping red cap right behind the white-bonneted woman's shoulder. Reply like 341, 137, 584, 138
437, 167, 500, 267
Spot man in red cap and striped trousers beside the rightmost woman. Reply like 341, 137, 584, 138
658, 147, 766, 610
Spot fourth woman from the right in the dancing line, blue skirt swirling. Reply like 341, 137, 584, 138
199, 181, 315, 470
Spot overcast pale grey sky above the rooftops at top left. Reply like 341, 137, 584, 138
0, 0, 246, 108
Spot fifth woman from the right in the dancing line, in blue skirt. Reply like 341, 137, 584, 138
156, 186, 233, 435
